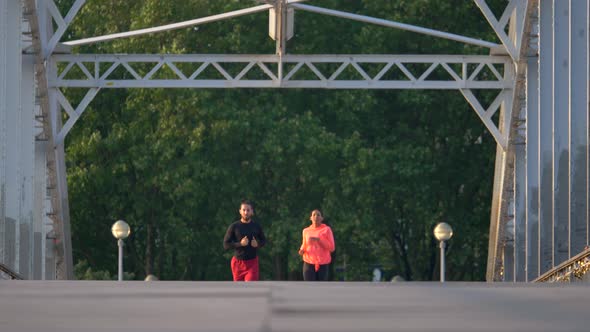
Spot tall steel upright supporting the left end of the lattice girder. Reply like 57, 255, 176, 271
22, 0, 75, 279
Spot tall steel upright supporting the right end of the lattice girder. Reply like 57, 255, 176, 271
488, 0, 536, 281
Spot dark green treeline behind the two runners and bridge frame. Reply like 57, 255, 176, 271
59, 0, 503, 280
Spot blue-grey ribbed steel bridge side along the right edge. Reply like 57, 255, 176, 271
500, 0, 590, 281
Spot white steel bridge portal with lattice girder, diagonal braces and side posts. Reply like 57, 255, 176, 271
5, 0, 527, 275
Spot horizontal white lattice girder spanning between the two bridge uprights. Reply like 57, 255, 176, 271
49, 54, 513, 90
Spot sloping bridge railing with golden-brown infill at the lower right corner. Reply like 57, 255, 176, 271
533, 246, 590, 282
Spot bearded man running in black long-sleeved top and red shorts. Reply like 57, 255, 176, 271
223, 200, 266, 281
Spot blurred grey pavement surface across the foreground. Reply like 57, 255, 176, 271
0, 280, 590, 332
